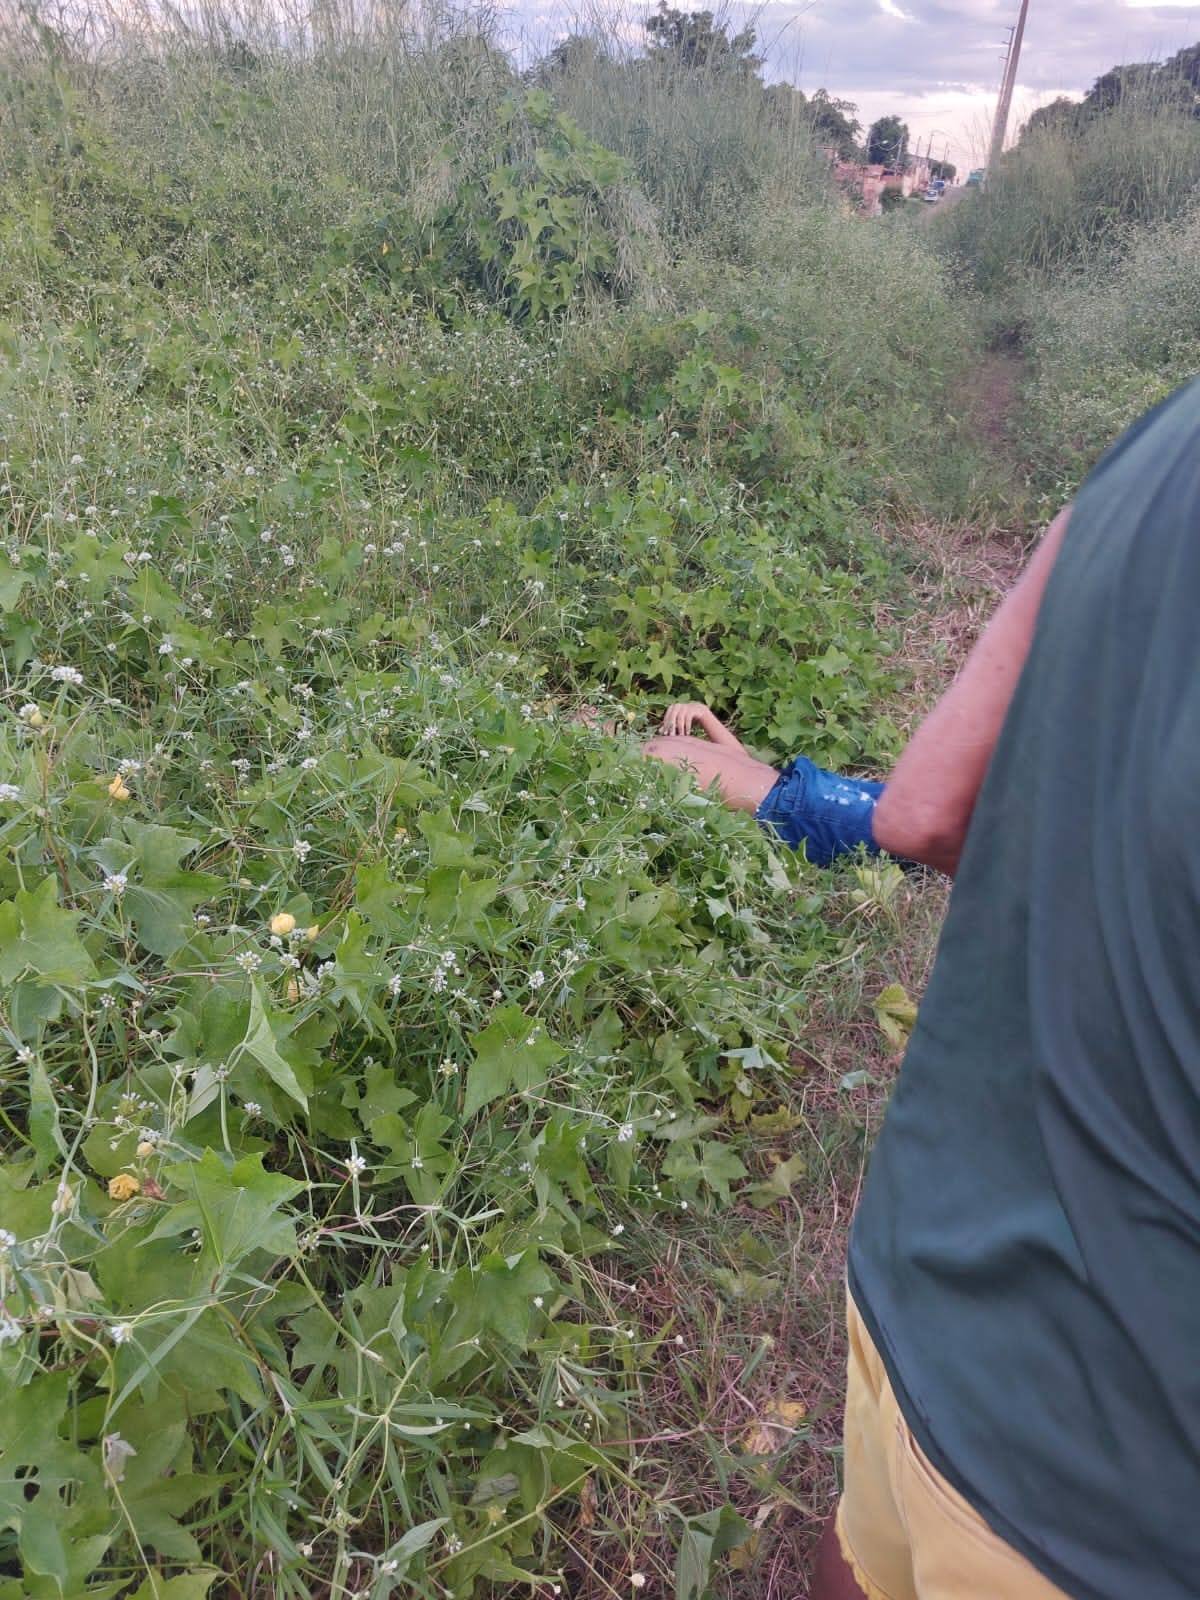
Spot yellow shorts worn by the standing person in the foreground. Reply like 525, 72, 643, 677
837, 1301, 1067, 1600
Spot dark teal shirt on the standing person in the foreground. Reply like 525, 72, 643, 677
850, 381, 1200, 1600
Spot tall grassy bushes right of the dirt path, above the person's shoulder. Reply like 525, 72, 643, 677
931, 46, 1200, 499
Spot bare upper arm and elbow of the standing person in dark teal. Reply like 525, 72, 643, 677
872, 507, 1070, 875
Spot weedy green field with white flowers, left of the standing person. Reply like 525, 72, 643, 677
0, 13, 1182, 1600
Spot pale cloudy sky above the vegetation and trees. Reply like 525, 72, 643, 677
502, 0, 1200, 168
